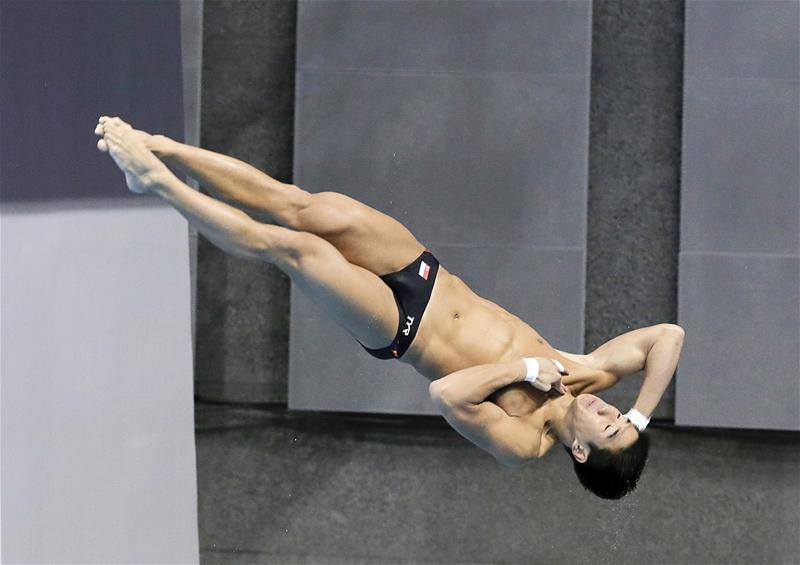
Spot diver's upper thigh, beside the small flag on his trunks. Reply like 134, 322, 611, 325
297, 192, 425, 275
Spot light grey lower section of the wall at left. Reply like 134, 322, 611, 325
0, 203, 198, 563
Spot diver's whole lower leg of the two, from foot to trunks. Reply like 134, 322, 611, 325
98, 118, 398, 349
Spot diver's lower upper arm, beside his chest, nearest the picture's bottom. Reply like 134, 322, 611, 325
432, 395, 541, 465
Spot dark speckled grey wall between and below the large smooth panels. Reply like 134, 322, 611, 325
197, 0, 800, 564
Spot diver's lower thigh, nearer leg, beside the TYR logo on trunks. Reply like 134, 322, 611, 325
268, 226, 399, 349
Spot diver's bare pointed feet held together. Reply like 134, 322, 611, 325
95, 116, 171, 194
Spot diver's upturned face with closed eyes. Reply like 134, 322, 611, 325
574, 394, 639, 451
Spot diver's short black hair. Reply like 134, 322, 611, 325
564, 432, 650, 500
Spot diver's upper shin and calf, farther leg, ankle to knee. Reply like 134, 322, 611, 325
148, 135, 287, 210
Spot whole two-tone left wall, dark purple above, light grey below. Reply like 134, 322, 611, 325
0, 2, 198, 563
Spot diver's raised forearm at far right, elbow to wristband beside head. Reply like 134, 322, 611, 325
634, 330, 683, 418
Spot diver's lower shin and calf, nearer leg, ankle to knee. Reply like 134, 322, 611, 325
149, 166, 255, 257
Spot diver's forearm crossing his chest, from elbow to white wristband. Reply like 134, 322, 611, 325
431, 359, 527, 405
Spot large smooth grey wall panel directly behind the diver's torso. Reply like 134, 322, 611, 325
289, 0, 591, 413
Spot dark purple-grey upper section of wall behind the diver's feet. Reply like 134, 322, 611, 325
0, 0, 184, 202
